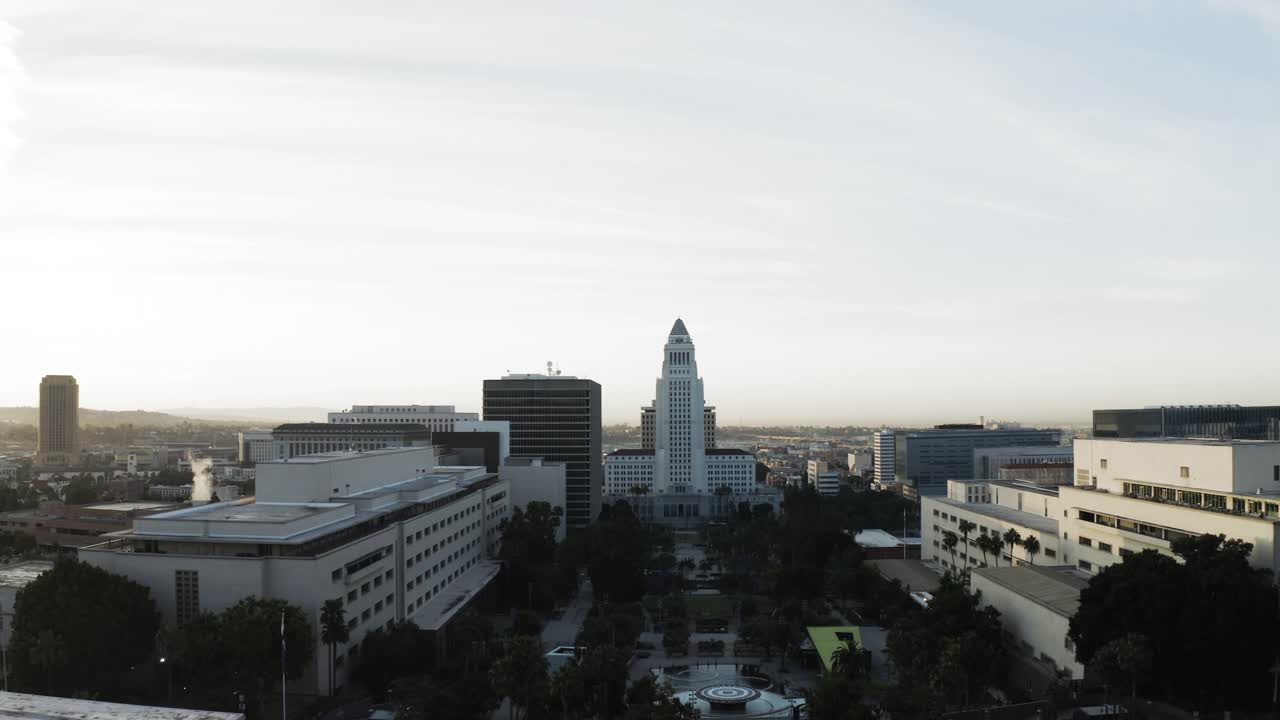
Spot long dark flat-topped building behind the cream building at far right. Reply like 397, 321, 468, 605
1093, 405, 1280, 439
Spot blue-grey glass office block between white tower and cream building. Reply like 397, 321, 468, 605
893, 425, 1062, 497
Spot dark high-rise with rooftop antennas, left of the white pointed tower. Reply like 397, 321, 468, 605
484, 375, 604, 532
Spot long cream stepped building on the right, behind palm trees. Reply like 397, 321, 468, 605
920, 438, 1280, 574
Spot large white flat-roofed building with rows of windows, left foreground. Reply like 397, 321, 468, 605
79, 447, 511, 692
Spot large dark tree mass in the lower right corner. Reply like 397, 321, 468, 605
1069, 536, 1280, 710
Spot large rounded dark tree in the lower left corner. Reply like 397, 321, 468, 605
9, 557, 160, 697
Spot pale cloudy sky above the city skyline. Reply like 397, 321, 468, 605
0, 0, 1280, 424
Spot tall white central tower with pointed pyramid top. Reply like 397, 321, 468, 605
654, 318, 708, 493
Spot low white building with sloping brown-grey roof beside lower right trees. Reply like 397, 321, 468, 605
970, 565, 1089, 680
